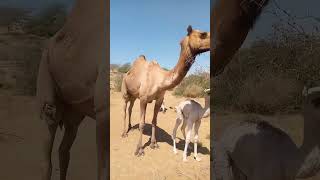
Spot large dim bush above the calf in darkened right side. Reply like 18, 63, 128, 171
213, 25, 320, 114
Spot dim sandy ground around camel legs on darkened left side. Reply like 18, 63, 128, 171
0, 96, 96, 180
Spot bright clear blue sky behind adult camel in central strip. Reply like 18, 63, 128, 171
110, 0, 210, 71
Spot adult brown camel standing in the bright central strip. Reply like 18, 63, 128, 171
121, 26, 210, 156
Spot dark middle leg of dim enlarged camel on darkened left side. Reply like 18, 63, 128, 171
59, 112, 84, 180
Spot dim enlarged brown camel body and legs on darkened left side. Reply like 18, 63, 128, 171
36, 0, 109, 180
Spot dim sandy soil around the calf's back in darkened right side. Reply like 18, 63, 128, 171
213, 112, 320, 180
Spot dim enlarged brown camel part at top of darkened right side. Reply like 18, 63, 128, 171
210, 0, 269, 77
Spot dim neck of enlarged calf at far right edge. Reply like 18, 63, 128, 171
296, 109, 320, 178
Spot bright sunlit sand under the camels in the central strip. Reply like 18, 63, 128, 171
110, 92, 210, 180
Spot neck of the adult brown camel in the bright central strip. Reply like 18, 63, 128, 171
163, 47, 195, 89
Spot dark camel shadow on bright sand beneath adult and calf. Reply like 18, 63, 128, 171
130, 123, 210, 156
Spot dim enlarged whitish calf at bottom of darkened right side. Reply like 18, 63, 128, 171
213, 83, 320, 180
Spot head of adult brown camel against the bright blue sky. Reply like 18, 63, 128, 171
180, 25, 210, 56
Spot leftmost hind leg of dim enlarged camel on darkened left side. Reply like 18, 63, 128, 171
36, 49, 60, 180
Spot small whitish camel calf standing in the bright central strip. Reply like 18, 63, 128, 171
172, 89, 210, 162
